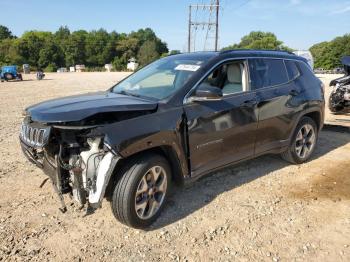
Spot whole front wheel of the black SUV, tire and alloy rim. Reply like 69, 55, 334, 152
111, 154, 171, 228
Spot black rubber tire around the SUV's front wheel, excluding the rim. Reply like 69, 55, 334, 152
111, 154, 171, 228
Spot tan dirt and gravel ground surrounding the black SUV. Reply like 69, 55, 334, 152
0, 73, 350, 261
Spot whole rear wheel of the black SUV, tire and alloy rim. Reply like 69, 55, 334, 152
281, 117, 318, 164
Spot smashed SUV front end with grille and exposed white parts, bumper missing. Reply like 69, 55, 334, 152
20, 116, 120, 213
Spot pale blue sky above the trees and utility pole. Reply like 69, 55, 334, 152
0, 0, 350, 51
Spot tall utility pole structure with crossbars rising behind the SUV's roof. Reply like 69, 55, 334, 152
187, 0, 220, 52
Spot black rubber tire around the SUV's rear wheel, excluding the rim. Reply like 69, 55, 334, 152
281, 116, 318, 164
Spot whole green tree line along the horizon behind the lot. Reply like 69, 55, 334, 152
0, 25, 350, 71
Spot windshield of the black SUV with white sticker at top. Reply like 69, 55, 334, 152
112, 56, 203, 100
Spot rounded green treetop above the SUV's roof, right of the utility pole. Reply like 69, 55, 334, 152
223, 31, 291, 51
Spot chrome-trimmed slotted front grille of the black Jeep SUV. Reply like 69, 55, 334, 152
20, 123, 50, 148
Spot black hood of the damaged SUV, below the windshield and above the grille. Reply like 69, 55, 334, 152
26, 91, 157, 123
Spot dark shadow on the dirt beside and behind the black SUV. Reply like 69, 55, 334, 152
148, 126, 350, 231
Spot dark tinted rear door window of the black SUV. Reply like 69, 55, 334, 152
249, 58, 289, 90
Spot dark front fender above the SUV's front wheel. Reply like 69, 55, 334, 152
95, 107, 188, 175
